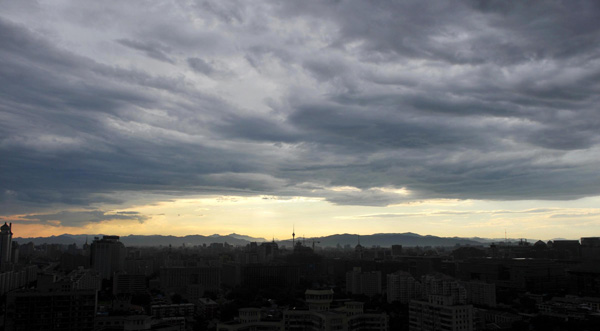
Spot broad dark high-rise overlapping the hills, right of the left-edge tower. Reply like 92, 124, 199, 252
91, 236, 126, 279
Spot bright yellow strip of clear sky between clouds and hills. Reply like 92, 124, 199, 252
7, 195, 600, 239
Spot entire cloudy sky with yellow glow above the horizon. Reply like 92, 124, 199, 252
0, 0, 600, 239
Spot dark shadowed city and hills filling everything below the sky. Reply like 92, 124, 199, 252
0, 224, 600, 331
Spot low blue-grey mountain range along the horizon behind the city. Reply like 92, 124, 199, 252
14, 232, 537, 247
